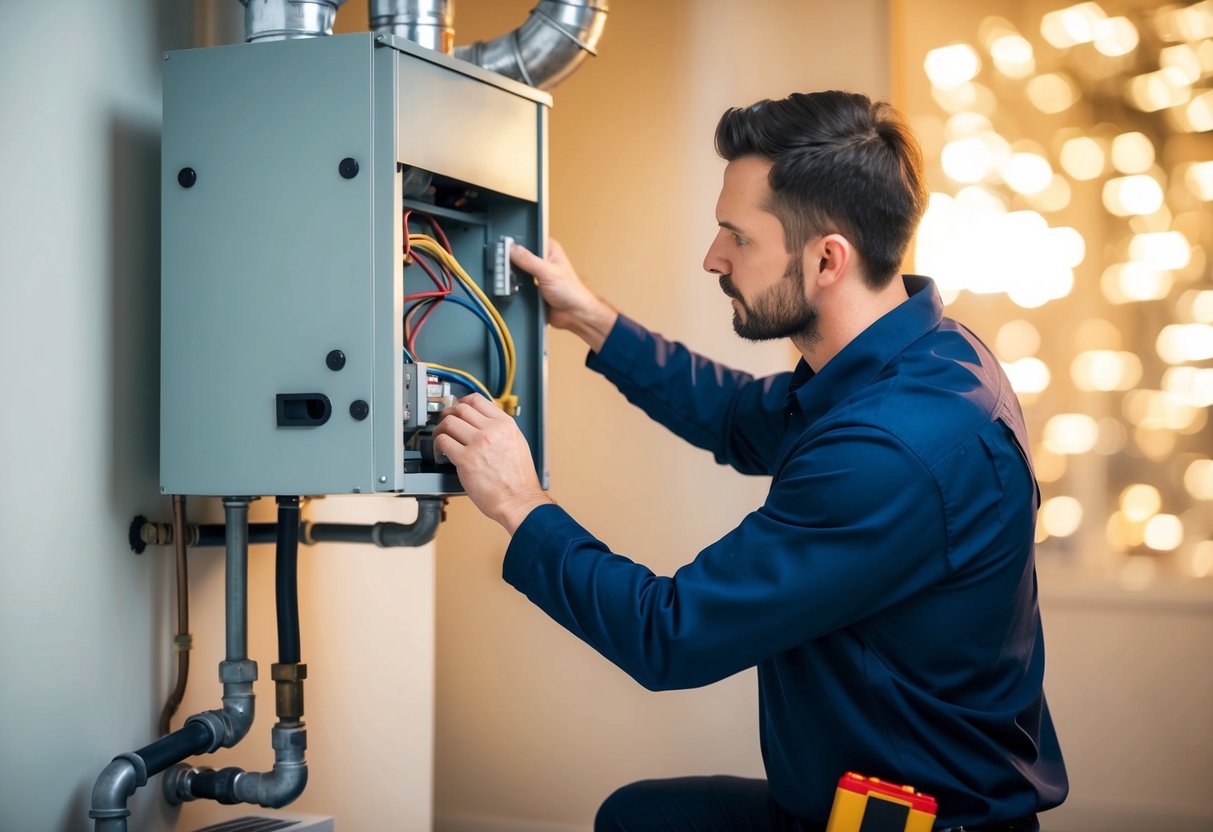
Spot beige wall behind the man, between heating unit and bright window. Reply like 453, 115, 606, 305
435, 0, 888, 832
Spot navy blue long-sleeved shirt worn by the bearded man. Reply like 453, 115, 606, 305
503, 277, 1067, 826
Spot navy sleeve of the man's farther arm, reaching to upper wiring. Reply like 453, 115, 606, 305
586, 315, 791, 474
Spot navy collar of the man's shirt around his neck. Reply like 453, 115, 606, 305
787, 274, 944, 423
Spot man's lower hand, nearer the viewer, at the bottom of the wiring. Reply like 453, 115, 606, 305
434, 393, 552, 535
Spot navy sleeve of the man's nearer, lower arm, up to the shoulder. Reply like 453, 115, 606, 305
503, 428, 949, 690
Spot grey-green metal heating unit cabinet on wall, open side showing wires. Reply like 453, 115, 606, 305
160, 34, 551, 495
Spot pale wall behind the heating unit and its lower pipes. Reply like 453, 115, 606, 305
0, 0, 434, 832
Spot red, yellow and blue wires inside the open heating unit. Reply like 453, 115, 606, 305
404, 211, 518, 415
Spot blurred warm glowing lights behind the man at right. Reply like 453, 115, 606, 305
915, 0, 1213, 587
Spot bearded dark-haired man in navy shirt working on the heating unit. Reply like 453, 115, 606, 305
435, 92, 1067, 832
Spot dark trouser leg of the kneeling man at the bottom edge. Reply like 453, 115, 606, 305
594, 776, 825, 832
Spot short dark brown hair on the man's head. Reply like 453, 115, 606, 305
716, 90, 927, 289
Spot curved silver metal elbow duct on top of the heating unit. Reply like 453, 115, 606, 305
455, 0, 608, 90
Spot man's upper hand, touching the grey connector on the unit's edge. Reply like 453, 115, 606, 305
509, 240, 619, 352
